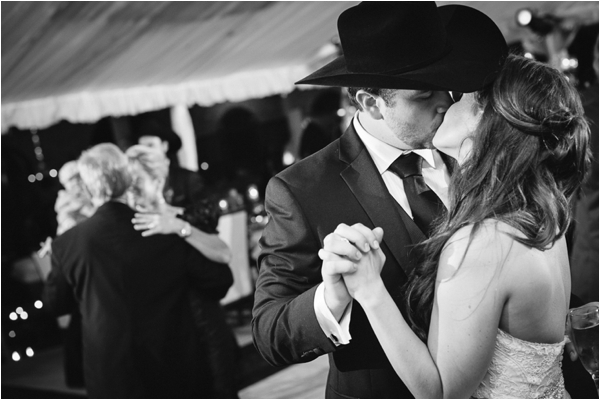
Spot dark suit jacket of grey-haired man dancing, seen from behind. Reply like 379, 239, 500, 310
44, 202, 233, 398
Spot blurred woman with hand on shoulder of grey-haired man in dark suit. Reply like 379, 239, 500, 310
127, 145, 238, 398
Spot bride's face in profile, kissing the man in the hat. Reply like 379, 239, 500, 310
433, 93, 483, 164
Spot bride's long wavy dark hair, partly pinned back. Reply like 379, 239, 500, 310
405, 55, 591, 341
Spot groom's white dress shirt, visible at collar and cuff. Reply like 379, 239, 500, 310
314, 112, 450, 346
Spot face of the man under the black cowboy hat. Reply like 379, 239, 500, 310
377, 89, 452, 149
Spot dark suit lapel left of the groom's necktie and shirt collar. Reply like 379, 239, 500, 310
340, 124, 422, 275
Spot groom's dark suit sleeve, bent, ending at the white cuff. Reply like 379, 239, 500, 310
252, 177, 335, 365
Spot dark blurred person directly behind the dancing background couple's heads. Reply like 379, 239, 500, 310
136, 120, 205, 207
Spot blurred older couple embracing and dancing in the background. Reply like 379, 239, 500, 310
44, 132, 237, 398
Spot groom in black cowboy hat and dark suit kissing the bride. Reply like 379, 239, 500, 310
252, 2, 507, 398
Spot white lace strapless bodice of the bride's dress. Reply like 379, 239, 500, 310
472, 329, 565, 399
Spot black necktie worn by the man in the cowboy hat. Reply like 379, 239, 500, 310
389, 152, 444, 236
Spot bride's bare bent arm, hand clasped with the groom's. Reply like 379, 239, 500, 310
322, 222, 505, 398
